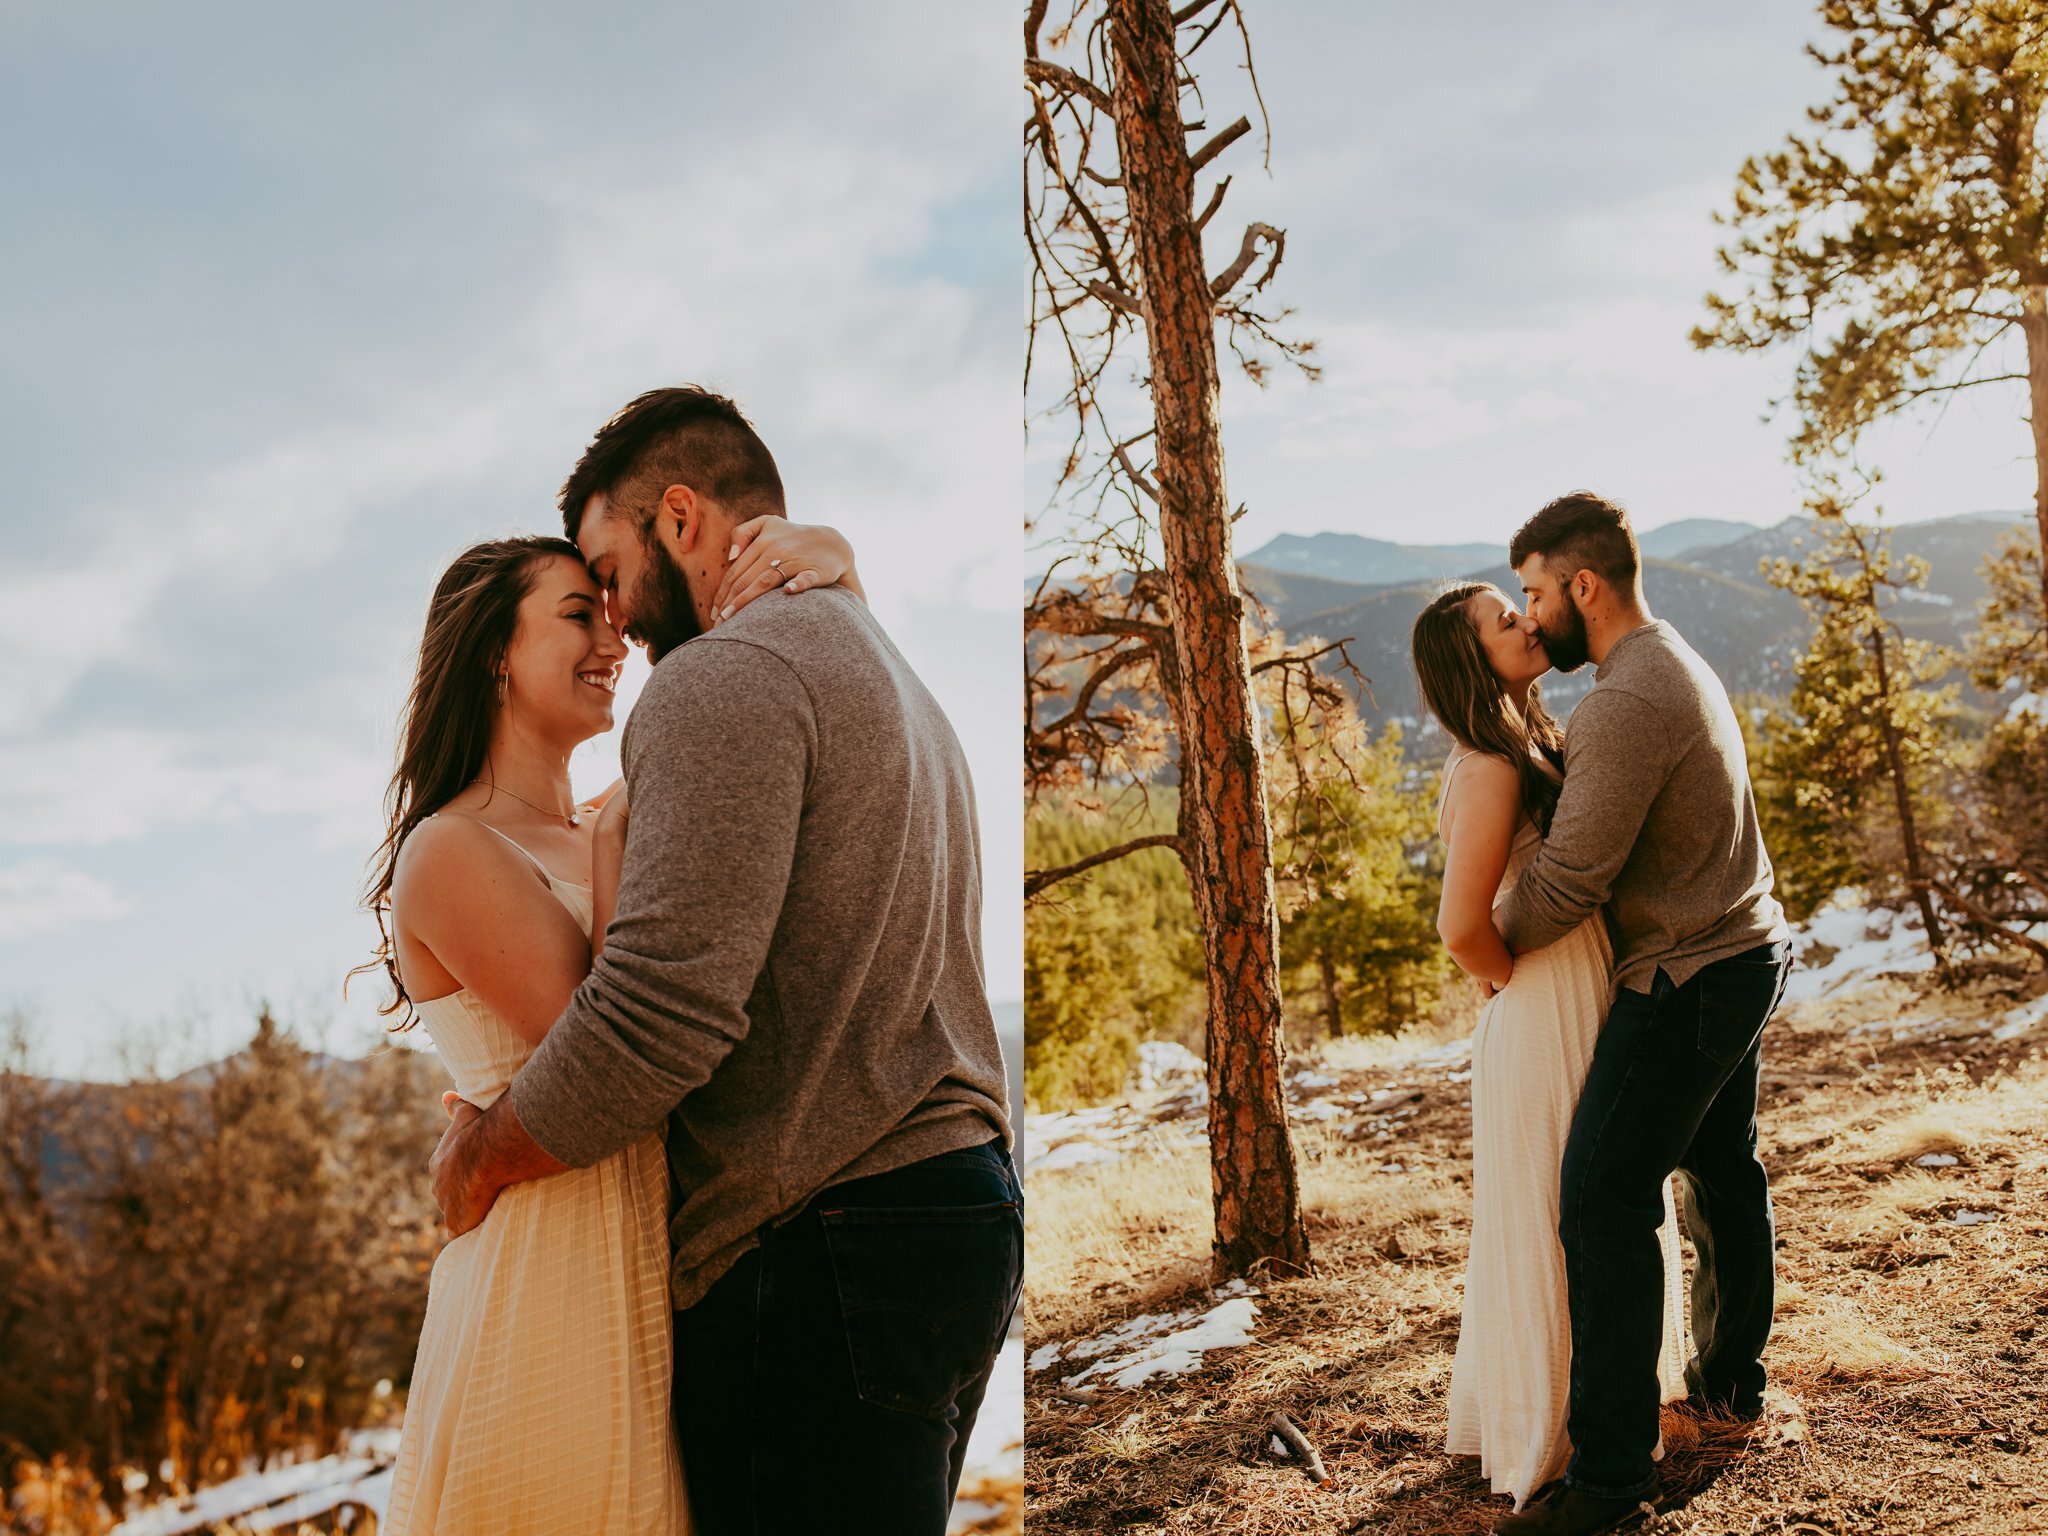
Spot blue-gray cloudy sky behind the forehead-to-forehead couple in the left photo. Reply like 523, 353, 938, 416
0, 0, 1022, 1075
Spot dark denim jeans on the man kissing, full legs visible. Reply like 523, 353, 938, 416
1559, 942, 1792, 1497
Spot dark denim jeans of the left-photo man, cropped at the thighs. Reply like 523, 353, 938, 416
674, 1141, 1024, 1536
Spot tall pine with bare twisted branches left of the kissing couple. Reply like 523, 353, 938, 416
1024, 0, 1309, 1278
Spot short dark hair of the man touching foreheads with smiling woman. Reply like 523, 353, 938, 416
561, 385, 784, 539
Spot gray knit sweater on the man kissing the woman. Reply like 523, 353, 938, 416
1495, 618, 1790, 991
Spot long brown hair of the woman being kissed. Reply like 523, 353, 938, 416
1409, 582, 1565, 834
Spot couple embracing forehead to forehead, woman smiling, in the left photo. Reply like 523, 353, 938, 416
369, 389, 1024, 1536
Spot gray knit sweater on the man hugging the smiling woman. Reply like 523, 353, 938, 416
510, 590, 1010, 1307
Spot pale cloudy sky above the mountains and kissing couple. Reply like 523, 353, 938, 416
1028, 0, 2034, 551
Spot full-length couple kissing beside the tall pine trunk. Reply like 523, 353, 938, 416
1413, 492, 1790, 1536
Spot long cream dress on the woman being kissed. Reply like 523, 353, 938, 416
1438, 754, 1686, 1509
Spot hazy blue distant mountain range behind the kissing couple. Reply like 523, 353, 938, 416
1239, 512, 2032, 719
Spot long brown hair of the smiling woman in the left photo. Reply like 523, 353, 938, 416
348, 535, 584, 1030
